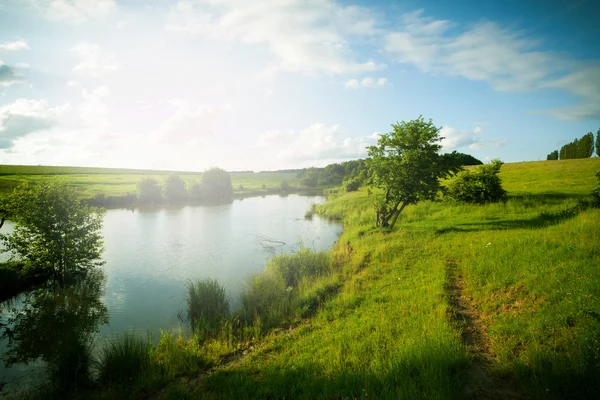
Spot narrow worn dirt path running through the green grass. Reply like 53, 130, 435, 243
446, 260, 527, 400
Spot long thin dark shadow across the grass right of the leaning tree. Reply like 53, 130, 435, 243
435, 200, 590, 234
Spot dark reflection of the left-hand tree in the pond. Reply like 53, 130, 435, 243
0, 269, 108, 391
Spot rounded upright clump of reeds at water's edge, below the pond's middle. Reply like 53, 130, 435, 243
186, 279, 229, 337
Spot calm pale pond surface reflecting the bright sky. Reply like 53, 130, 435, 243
0, 195, 342, 392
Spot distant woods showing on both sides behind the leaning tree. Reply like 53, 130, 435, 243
296, 150, 483, 191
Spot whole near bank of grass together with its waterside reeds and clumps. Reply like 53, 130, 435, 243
1, 159, 600, 399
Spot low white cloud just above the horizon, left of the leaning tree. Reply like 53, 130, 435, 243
256, 122, 377, 165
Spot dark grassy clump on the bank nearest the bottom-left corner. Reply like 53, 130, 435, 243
98, 333, 151, 384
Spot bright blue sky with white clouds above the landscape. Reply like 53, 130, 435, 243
0, 0, 600, 171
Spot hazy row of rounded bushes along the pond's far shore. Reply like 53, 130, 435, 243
86, 168, 233, 206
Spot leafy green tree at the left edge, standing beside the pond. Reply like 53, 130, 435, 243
0, 179, 103, 283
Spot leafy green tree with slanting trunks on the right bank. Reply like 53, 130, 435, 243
367, 116, 458, 228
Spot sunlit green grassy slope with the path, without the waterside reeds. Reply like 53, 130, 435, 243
143, 159, 600, 399
